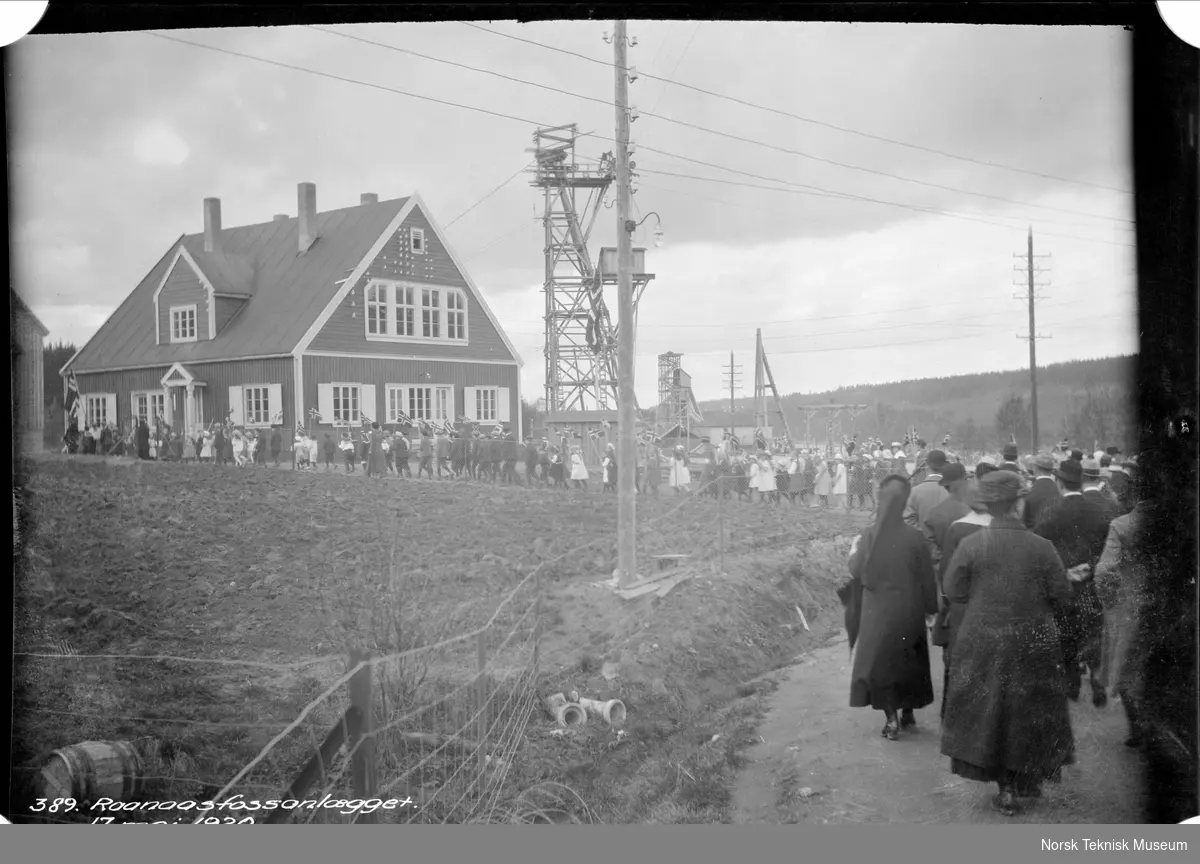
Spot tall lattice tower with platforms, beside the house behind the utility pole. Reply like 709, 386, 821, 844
530, 124, 617, 413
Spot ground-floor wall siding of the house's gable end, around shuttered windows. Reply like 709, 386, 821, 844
301, 355, 521, 431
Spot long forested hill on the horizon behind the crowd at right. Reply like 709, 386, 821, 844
701, 356, 1136, 451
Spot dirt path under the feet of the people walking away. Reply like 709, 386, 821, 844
736, 636, 1141, 824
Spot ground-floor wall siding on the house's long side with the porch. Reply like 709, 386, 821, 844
77, 358, 295, 440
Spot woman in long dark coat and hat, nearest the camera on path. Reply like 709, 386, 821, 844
942, 470, 1074, 816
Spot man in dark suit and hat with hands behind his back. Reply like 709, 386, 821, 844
1033, 460, 1112, 707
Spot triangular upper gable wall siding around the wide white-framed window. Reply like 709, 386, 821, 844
308, 209, 515, 360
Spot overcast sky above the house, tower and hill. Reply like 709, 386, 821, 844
7, 22, 1138, 406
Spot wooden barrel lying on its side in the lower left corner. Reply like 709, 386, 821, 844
40, 742, 144, 803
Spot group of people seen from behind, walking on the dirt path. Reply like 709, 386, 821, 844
840, 445, 1146, 815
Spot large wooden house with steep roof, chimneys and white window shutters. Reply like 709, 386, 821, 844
60, 182, 521, 446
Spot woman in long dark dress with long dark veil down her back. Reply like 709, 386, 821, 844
839, 475, 937, 740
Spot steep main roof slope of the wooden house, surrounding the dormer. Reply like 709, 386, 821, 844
68, 198, 408, 372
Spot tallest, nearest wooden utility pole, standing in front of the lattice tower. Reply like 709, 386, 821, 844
612, 20, 637, 588
